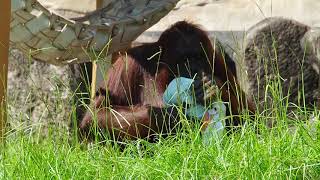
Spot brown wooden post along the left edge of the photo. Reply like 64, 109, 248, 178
0, 0, 11, 142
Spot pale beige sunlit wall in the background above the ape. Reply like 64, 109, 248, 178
40, 0, 320, 31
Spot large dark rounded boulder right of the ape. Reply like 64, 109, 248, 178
239, 18, 320, 107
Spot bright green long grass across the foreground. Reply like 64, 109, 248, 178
0, 107, 320, 179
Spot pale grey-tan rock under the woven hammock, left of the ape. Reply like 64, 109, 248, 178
8, 49, 72, 136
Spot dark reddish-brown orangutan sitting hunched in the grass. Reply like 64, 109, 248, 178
79, 21, 254, 141
